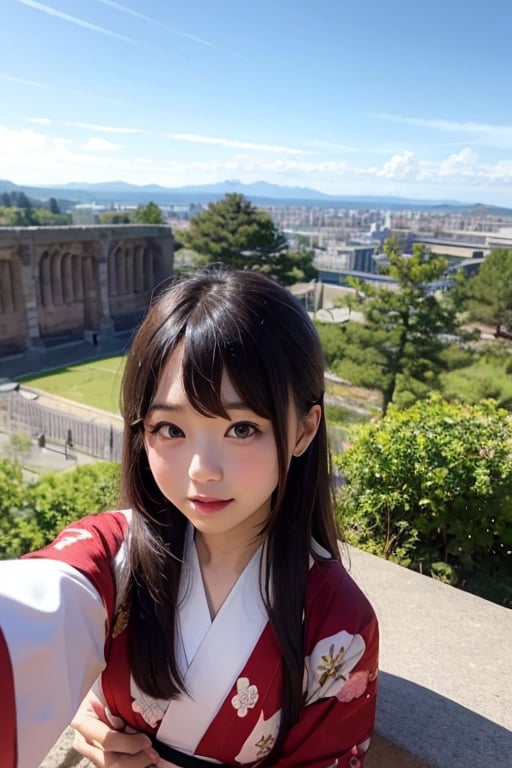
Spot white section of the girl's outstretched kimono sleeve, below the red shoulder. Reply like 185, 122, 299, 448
0, 560, 106, 768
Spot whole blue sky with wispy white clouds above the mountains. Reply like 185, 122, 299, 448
0, 0, 512, 207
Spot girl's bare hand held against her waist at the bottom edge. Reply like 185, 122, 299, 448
71, 692, 159, 768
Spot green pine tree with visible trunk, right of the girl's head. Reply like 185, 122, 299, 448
328, 240, 460, 413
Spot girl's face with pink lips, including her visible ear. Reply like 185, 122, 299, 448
144, 348, 316, 547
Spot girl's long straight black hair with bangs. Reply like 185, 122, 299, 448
121, 269, 339, 746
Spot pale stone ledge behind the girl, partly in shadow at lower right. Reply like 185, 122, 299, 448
41, 548, 512, 768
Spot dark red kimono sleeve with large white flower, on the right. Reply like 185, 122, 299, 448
273, 563, 379, 768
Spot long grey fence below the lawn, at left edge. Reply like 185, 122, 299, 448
0, 392, 123, 461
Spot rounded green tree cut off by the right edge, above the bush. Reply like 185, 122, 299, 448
466, 249, 512, 336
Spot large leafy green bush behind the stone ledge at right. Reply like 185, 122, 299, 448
336, 395, 512, 605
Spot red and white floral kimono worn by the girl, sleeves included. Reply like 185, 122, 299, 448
0, 512, 378, 768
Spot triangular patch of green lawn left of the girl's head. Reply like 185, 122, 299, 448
20, 356, 125, 413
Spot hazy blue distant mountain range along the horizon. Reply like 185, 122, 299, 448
0, 173, 512, 210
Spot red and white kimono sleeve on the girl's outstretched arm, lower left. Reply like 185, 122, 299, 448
0, 510, 129, 768
